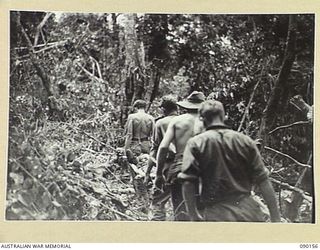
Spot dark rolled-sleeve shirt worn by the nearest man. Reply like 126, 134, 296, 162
178, 125, 269, 203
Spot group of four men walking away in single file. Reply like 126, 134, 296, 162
125, 91, 280, 222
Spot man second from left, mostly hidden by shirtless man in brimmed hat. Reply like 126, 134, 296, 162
145, 95, 177, 221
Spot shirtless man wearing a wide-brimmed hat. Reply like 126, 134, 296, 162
155, 91, 205, 221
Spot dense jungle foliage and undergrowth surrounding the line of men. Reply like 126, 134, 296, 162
6, 11, 314, 222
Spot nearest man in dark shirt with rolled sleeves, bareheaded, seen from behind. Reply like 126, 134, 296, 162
178, 100, 280, 222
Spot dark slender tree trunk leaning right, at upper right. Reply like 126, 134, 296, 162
258, 15, 297, 141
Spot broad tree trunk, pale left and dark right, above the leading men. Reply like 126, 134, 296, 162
122, 14, 169, 119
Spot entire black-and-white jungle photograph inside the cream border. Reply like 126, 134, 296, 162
5, 10, 317, 225
